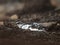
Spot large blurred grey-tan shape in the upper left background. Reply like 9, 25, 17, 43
0, 0, 25, 20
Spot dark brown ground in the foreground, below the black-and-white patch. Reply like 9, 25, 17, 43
0, 30, 60, 45
